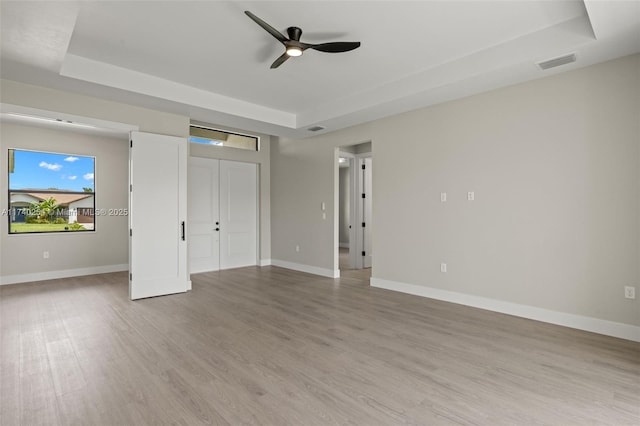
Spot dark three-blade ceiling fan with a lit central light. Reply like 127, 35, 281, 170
244, 10, 360, 69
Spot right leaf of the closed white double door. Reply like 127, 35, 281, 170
220, 161, 258, 269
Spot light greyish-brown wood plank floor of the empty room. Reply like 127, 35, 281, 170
0, 267, 640, 425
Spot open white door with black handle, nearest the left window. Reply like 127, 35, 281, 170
129, 132, 189, 300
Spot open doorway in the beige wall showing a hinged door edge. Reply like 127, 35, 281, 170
335, 142, 373, 275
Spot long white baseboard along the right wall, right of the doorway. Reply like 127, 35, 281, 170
371, 277, 640, 342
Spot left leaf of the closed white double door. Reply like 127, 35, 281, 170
189, 157, 220, 274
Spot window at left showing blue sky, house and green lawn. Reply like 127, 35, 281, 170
7, 149, 96, 234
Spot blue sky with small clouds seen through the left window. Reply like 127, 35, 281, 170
9, 150, 95, 191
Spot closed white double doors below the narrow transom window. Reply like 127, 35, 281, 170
187, 157, 258, 273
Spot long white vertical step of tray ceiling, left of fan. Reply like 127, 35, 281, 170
60, 54, 296, 129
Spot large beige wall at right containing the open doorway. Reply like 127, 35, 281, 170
272, 55, 640, 326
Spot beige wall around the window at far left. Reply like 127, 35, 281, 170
0, 123, 129, 279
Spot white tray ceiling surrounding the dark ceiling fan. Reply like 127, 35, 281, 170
0, 0, 640, 137
